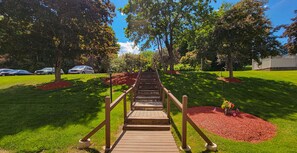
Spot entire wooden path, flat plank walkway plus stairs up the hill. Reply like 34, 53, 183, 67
111, 72, 179, 153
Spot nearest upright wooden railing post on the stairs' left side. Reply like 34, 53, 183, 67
105, 96, 111, 152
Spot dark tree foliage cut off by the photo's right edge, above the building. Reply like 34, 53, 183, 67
283, 10, 297, 54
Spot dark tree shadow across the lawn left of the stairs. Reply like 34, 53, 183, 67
0, 78, 108, 138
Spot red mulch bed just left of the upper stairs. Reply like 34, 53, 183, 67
104, 73, 138, 86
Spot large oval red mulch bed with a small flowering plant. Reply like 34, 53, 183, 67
188, 106, 276, 143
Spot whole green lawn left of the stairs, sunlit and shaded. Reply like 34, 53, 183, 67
0, 74, 127, 153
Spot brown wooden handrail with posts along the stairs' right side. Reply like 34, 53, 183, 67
156, 69, 216, 151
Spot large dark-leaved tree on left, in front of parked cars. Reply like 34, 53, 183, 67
0, 0, 116, 81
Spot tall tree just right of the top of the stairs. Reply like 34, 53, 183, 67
121, 0, 211, 70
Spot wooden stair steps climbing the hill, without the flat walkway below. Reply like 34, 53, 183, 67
124, 72, 170, 131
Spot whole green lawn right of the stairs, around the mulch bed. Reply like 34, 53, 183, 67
161, 71, 297, 153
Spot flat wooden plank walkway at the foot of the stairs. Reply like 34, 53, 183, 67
112, 131, 179, 153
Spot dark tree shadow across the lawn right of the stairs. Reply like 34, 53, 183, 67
161, 72, 297, 121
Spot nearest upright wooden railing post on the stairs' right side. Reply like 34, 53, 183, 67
182, 95, 191, 151
